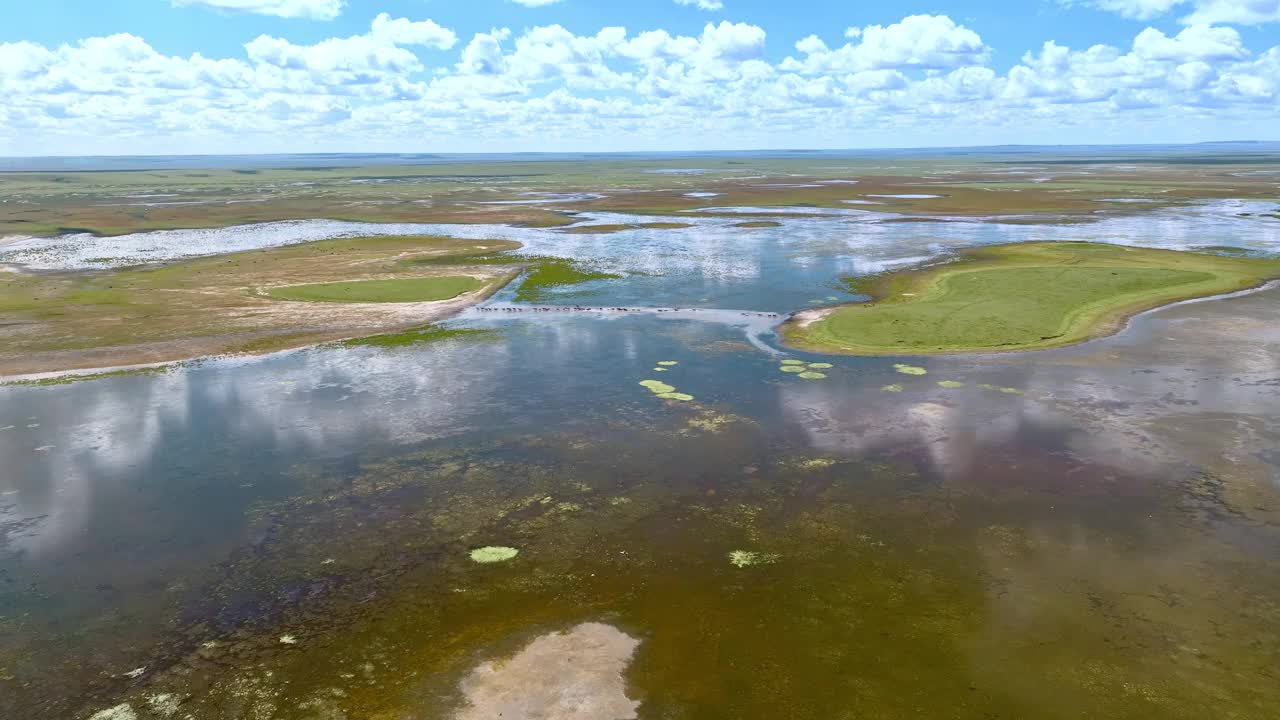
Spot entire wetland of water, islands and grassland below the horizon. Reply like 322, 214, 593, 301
0, 151, 1280, 720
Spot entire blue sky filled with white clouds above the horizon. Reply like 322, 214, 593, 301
0, 0, 1280, 155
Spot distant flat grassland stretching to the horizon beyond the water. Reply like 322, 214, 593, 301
0, 154, 1280, 237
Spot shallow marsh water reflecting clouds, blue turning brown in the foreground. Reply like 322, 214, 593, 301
0, 204, 1280, 720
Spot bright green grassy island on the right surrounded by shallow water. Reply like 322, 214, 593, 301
782, 242, 1280, 355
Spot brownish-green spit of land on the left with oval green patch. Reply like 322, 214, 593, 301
0, 237, 526, 375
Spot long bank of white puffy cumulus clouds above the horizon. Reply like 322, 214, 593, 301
0, 14, 1280, 154
